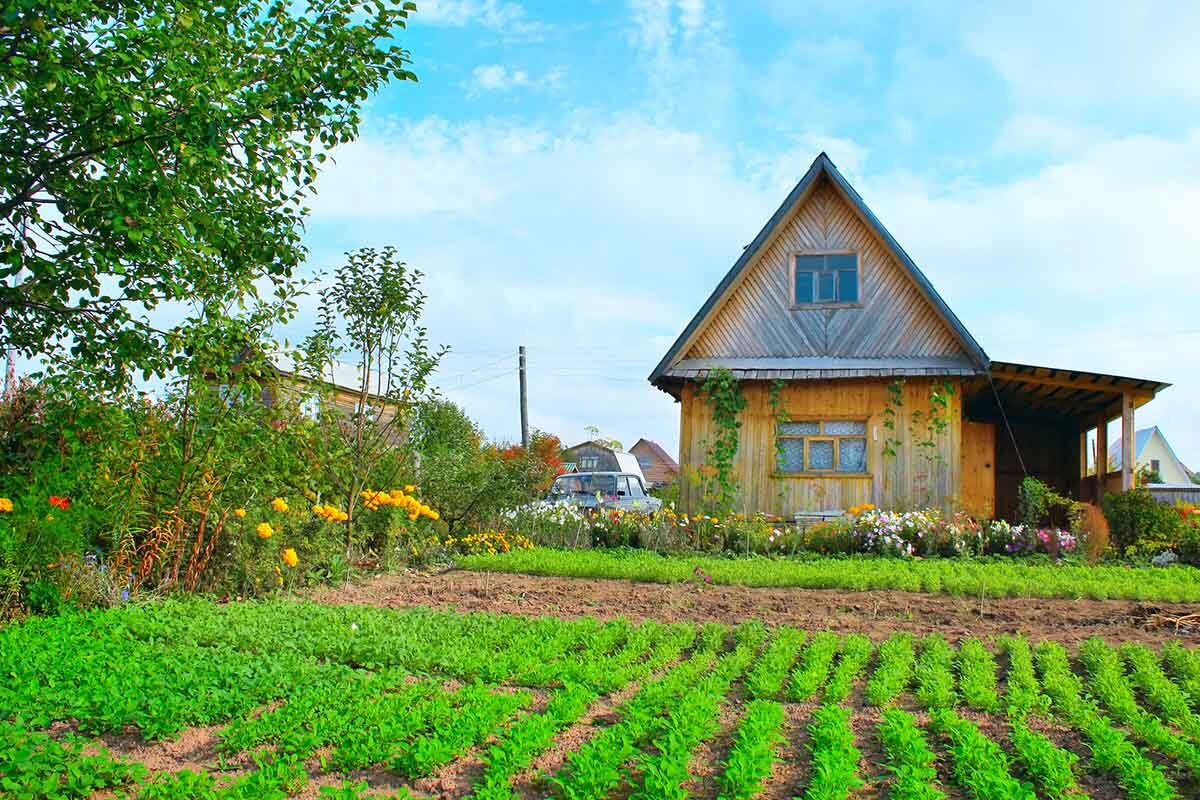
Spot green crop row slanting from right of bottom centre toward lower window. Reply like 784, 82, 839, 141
632, 622, 766, 800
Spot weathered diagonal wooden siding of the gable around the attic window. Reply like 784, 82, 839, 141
685, 179, 965, 359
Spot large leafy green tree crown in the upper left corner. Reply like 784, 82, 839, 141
0, 0, 415, 383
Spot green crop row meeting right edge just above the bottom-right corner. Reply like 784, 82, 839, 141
1079, 638, 1200, 777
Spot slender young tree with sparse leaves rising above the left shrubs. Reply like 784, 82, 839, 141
296, 247, 446, 553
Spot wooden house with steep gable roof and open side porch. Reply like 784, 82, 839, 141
649, 154, 1166, 516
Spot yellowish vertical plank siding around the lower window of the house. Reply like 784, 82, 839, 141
679, 378, 962, 517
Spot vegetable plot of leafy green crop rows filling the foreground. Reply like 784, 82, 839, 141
7, 600, 1200, 800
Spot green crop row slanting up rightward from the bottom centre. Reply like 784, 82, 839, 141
551, 626, 722, 800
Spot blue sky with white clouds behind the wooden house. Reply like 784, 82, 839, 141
286, 0, 1200, 467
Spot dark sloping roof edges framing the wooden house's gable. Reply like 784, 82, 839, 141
649, 152, 989, 385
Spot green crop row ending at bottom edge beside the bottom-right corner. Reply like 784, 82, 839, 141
1034, 642, 1177, 800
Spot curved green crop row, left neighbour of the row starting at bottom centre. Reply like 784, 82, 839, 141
472, 622, 696, 800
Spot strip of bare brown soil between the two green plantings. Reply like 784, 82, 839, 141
312, 570, 1200, 643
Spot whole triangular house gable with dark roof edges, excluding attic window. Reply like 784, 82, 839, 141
650, 154, 988, 383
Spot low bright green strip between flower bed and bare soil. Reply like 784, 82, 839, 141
460, 548, 1200, 602
